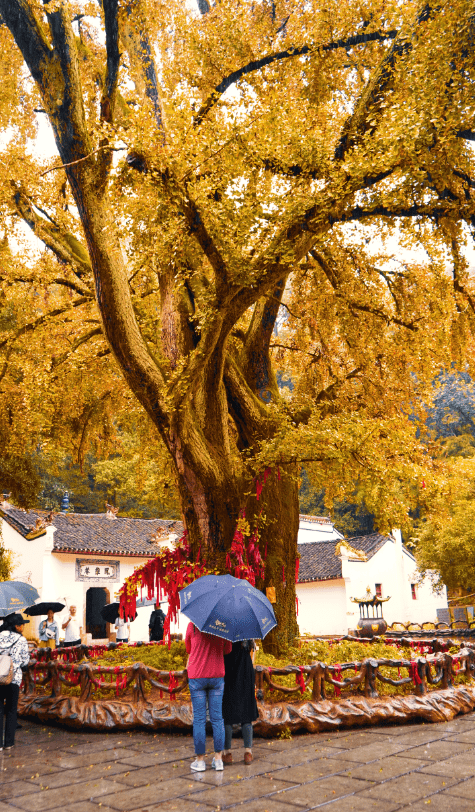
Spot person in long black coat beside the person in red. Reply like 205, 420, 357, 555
223, 640, 259, 764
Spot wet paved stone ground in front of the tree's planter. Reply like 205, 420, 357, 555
0, 713, 475, 812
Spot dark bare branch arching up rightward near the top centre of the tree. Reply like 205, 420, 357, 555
193, 30, 397, 127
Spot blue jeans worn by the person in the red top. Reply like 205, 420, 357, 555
189, 677, 224, 756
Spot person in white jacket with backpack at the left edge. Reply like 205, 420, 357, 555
0, 614, 30, 750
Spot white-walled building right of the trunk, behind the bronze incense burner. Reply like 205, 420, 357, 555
297, 516, 447, 635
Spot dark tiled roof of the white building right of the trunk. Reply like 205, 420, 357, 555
298, 533, 394, 584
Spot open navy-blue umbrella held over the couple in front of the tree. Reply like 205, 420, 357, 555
178, 575, 277, 643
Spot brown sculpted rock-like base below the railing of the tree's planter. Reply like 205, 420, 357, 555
18, 685, 475, 738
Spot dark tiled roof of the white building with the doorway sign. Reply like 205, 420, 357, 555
2, 507, 183, 556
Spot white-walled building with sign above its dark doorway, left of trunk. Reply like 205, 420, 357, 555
0, 502, 183, 642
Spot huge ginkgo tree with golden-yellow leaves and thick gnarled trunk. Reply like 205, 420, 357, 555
0, 0, 475, 649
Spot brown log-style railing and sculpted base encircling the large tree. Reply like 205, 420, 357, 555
19, 641, 475, 736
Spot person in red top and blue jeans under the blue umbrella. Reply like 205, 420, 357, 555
185, 623, 232, 772
